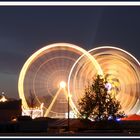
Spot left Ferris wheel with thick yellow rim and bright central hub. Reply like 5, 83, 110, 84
18, 43, 102, 118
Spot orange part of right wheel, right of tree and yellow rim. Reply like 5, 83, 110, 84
90, 46, 140, 114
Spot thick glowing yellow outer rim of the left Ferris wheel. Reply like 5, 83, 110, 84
18, 43, 103, 109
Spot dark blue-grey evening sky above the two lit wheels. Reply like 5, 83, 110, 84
0, 6, 140, 98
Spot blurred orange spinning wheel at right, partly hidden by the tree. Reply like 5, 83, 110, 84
68, 46, 140, 114
